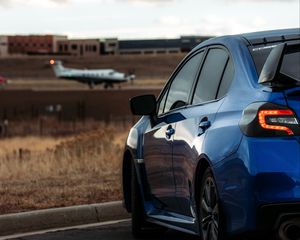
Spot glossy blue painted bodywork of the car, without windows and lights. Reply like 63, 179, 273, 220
122, 29, 300, 234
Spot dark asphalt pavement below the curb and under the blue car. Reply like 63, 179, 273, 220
0, 219, 277, 240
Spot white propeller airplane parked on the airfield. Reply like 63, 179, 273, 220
50, 59, 135, 89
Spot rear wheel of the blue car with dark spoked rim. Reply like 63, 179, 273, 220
198, 168, 225, 240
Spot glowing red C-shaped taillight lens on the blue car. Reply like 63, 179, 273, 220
258, 110, 298, 135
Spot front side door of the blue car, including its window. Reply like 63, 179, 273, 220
143, 52, 203, 211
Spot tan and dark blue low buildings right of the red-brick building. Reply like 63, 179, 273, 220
58, 36, 210, 57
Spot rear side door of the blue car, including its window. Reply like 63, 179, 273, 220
173, 47, 233, 217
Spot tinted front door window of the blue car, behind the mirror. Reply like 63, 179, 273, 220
160, 52, 203, 112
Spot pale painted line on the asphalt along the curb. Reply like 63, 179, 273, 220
0, 218, 131, 240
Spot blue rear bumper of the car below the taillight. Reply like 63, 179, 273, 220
216, 137, 300, 233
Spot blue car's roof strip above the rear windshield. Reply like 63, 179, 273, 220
238, 28, 300, 45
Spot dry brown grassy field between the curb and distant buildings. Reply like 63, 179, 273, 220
0, 54, 173, 214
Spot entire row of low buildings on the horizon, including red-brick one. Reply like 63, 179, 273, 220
0, 35, 211, 58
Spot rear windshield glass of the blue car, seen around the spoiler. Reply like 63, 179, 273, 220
249, 41, 300, 81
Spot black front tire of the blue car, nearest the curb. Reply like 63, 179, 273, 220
131, 164, 147, 238
